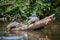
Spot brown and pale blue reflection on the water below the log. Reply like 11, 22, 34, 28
0, 31, 46, 40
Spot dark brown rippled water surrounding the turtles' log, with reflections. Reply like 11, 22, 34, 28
0, 20, 60, 40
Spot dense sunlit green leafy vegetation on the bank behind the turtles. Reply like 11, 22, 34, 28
0, 0, 60, 20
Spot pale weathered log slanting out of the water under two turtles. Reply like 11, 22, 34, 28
6, 14, 55, 30
